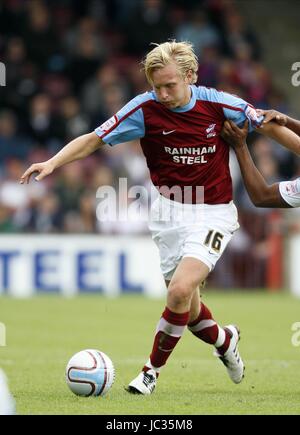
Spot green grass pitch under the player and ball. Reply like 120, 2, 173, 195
0, 290, 300, 415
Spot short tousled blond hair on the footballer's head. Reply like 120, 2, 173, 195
142, 40, 198, 84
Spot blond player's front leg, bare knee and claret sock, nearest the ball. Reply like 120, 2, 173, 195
129, 258, 209, 394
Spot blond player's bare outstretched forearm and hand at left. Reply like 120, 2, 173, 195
20, 132, 104, 184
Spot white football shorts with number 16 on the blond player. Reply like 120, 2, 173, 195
149, 195, 239, 281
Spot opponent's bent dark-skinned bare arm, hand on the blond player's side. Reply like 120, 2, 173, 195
221, 121, 290, 208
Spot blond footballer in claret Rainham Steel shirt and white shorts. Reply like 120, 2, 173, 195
21, 41, 300, 395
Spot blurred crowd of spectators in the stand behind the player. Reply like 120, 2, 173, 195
0, 0, 300, 286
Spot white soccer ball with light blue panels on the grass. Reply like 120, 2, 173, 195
66, 349, 115, 397
